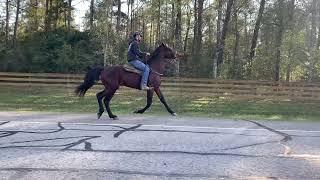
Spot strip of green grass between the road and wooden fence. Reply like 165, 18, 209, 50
0, 87, 320, 120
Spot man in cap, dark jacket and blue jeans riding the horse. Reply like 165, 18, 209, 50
128, 32, 153, 91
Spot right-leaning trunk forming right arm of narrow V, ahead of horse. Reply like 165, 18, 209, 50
217, 0, 234, 65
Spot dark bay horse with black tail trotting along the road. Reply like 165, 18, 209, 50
75, 43, 181, 119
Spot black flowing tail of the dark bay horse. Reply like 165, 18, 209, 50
74, 67, 103, 97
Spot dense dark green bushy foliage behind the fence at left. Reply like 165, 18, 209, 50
0, 30, 103, 73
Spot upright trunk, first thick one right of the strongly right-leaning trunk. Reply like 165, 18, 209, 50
274, 0, 284, 81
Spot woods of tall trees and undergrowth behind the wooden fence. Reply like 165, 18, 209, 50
0, 0, 320, 82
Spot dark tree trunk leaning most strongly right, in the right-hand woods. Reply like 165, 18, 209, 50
248, 0, 266, 78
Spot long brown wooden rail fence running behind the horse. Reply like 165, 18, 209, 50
0, 72, 320, 102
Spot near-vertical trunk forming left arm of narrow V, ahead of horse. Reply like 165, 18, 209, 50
212, 0, 223, 79
